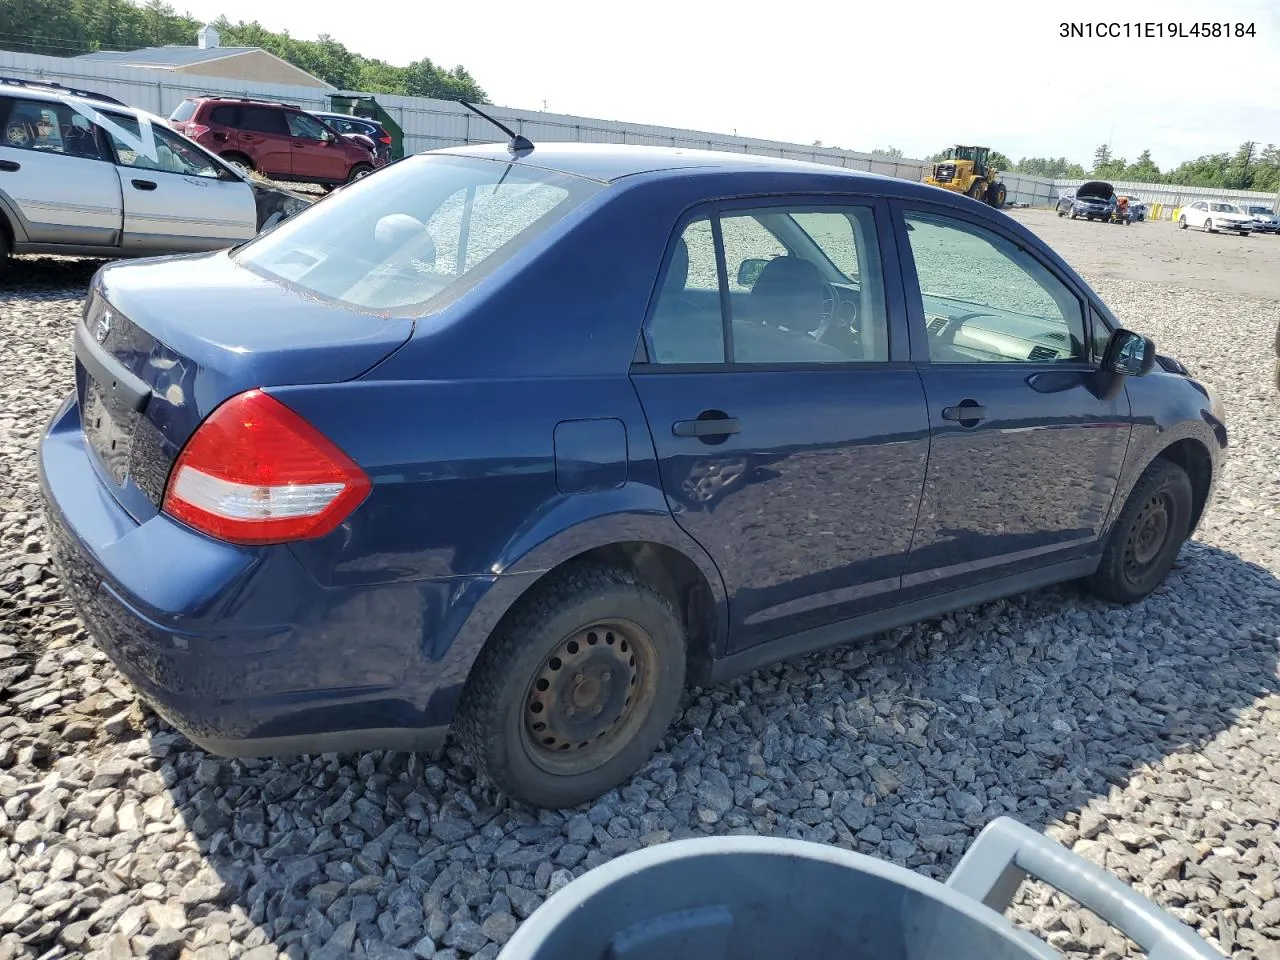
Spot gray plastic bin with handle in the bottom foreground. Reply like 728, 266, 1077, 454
498, 818, 1221, 960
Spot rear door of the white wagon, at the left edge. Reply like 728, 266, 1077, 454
0, 97, 123, 247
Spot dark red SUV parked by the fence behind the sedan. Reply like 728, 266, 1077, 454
169, 97, 379, 187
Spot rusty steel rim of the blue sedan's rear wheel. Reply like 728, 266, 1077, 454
520, 620, 657, 776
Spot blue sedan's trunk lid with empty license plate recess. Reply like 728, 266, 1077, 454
76, 252, 413, 522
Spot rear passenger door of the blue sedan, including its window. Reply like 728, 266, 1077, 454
632, 197, 928, 650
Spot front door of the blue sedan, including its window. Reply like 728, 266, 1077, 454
895, 204, 1132, 593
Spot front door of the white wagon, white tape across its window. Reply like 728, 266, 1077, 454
102, 113, 257, 253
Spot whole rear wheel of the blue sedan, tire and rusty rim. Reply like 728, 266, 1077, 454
453, 563, 685, 809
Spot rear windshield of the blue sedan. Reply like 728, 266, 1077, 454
233, 155, 603, 316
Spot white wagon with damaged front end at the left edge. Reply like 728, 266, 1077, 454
0, 78, 312, 262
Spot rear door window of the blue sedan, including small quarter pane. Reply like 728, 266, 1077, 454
648, 205, 888, 365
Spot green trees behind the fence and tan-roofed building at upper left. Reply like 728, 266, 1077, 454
0, 0, 489, 104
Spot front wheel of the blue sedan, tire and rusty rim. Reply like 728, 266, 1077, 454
1088, 460, 1194, 603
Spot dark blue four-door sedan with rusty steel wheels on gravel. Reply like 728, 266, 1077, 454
40, 143, 1228, 808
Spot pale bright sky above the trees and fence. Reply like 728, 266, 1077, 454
174, 0, 1280, 168
